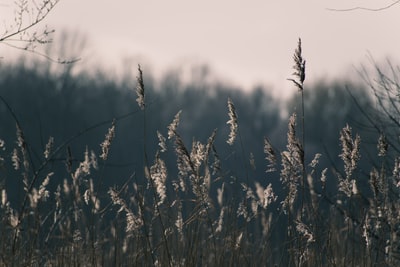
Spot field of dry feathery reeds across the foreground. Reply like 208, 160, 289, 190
0, 40, 400, 266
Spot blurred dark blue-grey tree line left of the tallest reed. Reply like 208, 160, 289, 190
0, 61, 279, 197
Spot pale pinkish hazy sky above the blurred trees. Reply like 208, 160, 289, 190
0, 0, 400, 98
